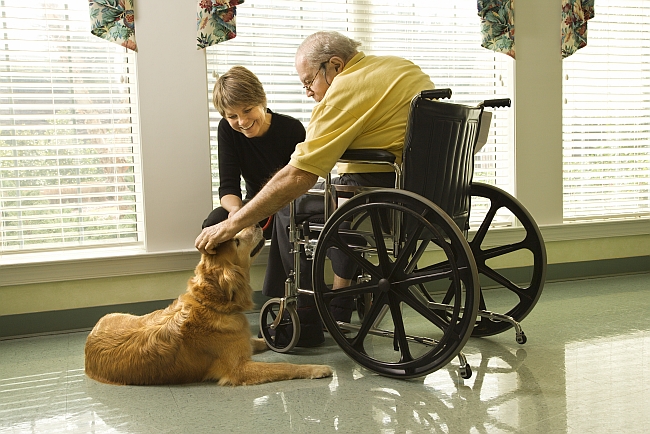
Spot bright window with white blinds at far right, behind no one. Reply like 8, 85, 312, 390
563, 0, 650, 222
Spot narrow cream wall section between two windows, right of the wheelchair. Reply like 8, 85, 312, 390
514, 0, 563, 226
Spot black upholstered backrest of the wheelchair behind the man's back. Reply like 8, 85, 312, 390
403, 94, 483, 231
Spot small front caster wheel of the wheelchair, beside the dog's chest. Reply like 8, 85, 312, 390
260, 298, 300, 353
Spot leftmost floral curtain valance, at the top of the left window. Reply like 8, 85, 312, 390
88, 0, 138, 51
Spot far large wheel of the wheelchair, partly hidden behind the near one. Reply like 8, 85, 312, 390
469, 183, 546, 343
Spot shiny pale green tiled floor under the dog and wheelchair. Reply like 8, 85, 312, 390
0, 274, 650, 434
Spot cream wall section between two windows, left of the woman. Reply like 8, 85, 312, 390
135, 0, 212, 252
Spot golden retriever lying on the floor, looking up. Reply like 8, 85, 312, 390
85, 226, 332, 386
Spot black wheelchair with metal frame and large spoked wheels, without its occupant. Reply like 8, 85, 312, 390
260, 89, 546, 378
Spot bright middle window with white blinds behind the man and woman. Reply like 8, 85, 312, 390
207, 0, 513, 210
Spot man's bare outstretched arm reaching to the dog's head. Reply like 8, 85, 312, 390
194, 165, 318, 253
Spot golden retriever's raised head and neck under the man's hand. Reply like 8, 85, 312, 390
192, 225, 264, 312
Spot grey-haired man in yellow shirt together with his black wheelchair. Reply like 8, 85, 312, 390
196, 32, 546, 378
